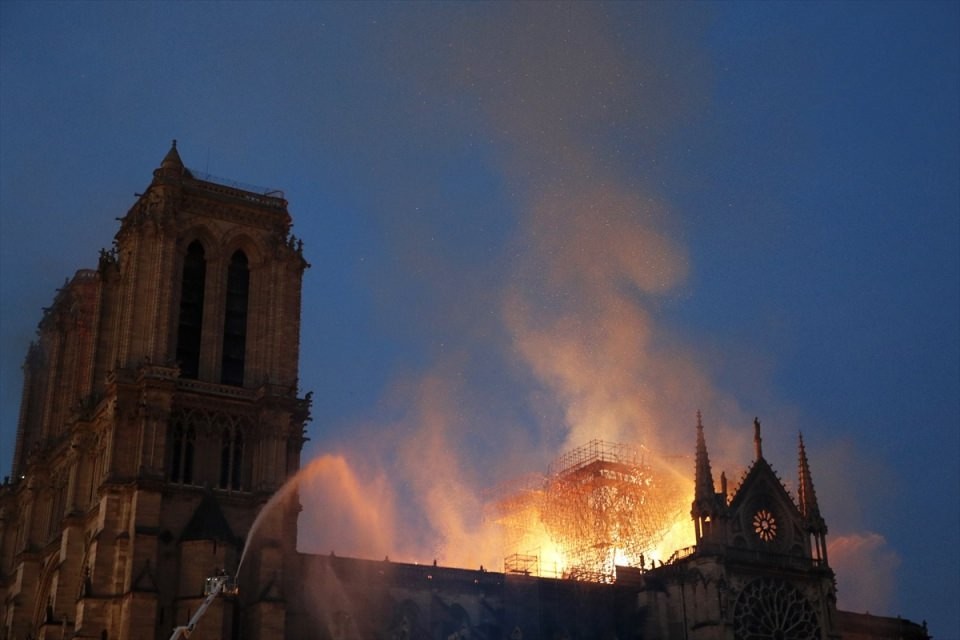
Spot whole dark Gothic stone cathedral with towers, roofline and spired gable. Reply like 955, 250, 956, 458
0, 148, 929, 640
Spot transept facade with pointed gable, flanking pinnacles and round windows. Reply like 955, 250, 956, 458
660, 415, 840, 640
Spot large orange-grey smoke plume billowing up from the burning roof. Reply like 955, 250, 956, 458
292, 3, 890, 616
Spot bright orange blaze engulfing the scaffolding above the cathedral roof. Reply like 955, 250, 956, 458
496, 440, 693, 582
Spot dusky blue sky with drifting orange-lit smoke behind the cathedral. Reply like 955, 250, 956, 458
0, 2, 960, 637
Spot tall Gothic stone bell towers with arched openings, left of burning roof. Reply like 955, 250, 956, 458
0, 143, 309, 640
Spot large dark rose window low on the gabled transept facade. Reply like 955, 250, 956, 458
733, 578, 821, 640
